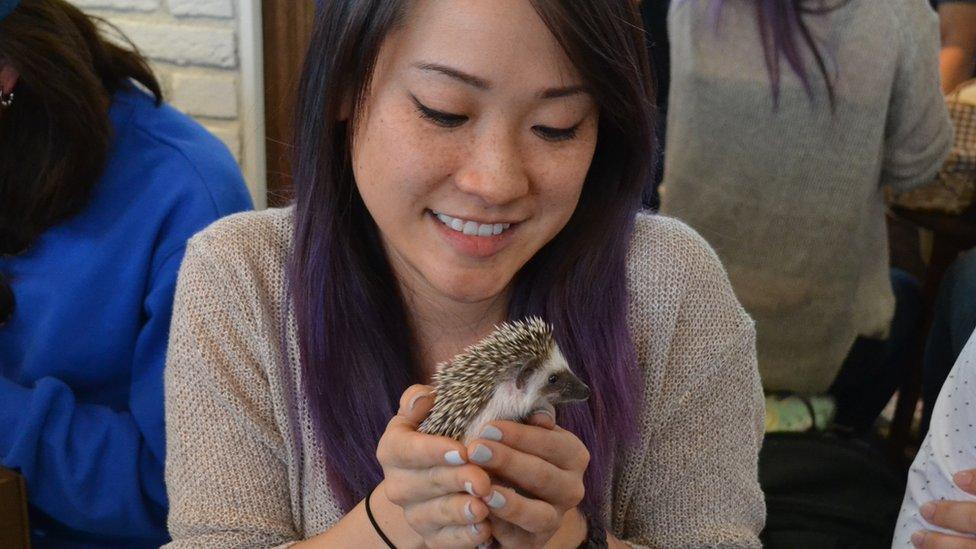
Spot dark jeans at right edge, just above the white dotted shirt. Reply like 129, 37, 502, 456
921, 249, 976, 436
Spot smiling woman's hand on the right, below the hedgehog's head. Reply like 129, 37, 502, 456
468, 408, 590, 547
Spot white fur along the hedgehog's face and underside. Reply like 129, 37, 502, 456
461, 346, 569, 444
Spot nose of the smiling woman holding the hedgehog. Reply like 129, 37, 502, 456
455, 125, 529, 206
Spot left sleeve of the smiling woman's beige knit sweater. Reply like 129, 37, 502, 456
165, 237, 300, 548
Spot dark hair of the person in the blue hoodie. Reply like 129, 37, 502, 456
0, 0, 162, 255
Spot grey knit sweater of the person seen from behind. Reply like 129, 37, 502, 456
662, 0, 952, 392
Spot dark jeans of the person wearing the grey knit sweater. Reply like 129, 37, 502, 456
829, 269, 922, 433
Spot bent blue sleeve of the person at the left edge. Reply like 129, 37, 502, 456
0, 248, 183, 543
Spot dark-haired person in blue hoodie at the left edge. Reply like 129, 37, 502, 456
0, 0, 251, 547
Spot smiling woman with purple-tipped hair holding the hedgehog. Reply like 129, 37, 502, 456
166, 0, 763, 548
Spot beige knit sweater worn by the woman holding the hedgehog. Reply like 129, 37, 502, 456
166, 209, 765, 548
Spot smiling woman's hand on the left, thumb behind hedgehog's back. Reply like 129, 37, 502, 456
376, 385, 492, 549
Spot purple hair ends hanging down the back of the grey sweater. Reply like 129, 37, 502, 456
712, 0, 850, 108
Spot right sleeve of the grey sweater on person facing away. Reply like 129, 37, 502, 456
881, 2, 953, 191
